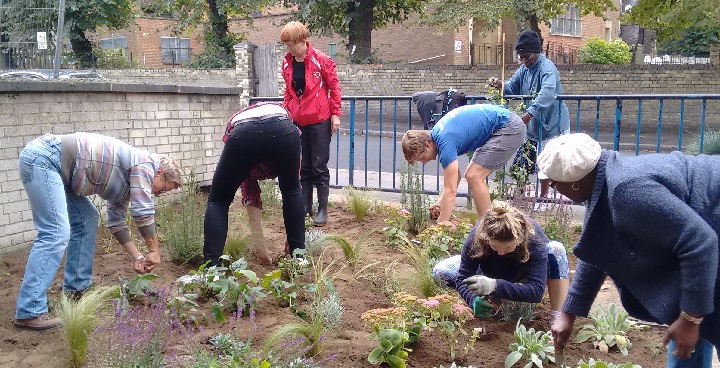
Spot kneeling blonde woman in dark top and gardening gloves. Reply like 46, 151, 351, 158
433, 201, 569, 326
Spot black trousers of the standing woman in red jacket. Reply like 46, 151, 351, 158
298, 119, 332, 188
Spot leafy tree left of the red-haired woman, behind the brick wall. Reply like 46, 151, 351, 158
156, 0, 274, 68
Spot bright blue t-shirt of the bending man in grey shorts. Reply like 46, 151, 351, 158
430, 104, 510, 169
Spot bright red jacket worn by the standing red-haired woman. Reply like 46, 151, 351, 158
282, 41, 342, 126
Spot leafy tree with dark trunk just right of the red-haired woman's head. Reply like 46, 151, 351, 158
289, 0, 426, 63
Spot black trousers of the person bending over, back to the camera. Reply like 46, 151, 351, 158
203, 117, 305, 265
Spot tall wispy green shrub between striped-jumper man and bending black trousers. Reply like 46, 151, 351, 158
157, 172, 205, 264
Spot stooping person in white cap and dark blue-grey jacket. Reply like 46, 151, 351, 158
538, 133, 720, 368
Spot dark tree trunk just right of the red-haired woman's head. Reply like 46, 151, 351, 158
347, 0, 375, 64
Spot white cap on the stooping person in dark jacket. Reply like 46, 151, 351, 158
537, 133, 602, 183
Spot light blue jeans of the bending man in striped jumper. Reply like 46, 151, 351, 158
15, 134, 100, 319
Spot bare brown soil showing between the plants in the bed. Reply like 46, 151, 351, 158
0, 194, 665, 368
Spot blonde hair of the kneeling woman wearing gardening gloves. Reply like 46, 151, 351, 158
470, 201, 535, 262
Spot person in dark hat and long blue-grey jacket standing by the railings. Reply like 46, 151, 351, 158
488, 30, 570, 197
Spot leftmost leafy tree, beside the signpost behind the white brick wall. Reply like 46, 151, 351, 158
65, 0, 137, 67
